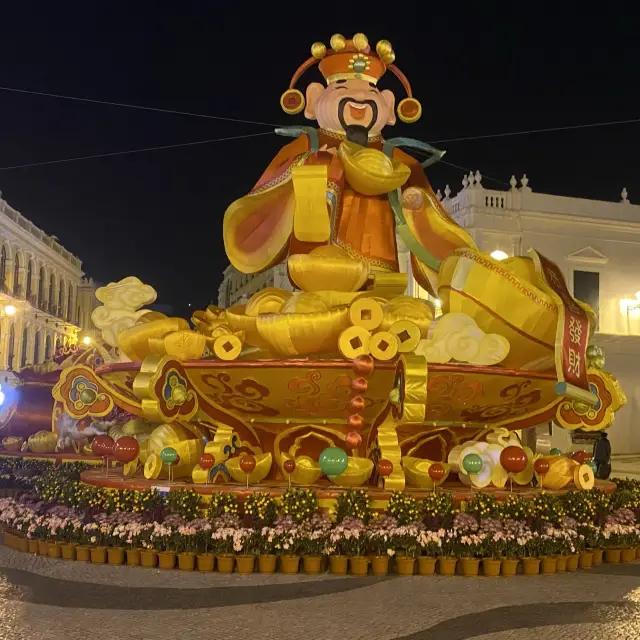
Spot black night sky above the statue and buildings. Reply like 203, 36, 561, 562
0, 2, 640, 314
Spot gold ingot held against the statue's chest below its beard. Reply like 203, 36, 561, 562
338, 140, 411, 196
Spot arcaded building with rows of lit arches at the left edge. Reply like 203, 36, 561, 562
0, 198, 97, 370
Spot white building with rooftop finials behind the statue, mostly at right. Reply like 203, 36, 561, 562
219, 172, 640, 453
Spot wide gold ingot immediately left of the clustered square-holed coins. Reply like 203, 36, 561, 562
256, 307, 349, 356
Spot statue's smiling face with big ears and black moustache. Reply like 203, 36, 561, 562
304, 80, 396, 140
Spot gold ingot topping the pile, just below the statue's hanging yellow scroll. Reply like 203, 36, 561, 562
287, 245, 369, 293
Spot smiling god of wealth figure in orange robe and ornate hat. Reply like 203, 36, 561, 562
224, 33, 475, 294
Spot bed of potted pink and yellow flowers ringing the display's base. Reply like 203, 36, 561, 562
0, 480, 640, 576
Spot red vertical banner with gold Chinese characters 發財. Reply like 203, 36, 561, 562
531, 249, 589, 391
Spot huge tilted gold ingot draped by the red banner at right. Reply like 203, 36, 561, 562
438, 249, 558, 370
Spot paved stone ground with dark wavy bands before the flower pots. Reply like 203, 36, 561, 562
0, 547, 640, 640
